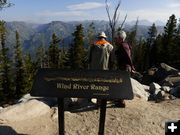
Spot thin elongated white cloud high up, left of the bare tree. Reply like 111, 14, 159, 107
67, 2, 105, 10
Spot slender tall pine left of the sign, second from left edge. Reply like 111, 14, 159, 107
14, 30, 25, 97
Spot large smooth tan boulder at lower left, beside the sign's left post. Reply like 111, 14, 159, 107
0, 99, 50, 124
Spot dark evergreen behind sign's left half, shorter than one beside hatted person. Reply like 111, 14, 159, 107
49, 33, 61, 68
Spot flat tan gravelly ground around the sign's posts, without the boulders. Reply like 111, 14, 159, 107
0, 97, 180, 135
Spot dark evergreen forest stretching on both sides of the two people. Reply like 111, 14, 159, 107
0, 0, 180, 106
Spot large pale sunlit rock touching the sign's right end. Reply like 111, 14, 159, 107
131, 78, 150, 100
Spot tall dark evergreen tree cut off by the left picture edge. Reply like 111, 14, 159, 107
0, 21, 13, 97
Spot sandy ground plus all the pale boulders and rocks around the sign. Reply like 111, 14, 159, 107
0, 63, 180, 135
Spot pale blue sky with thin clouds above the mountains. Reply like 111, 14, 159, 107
0, 0, 180, 24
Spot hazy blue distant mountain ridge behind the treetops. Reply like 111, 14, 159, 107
6, 20, 163, 55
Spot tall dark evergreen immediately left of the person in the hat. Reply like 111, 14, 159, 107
71, 24, 85, 69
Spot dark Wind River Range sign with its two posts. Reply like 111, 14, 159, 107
30, 69, 133, 135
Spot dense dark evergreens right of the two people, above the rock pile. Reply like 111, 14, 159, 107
133, 15, 180, 71
